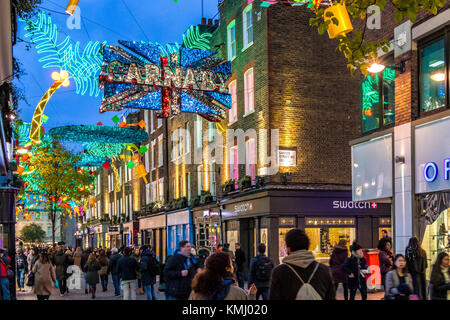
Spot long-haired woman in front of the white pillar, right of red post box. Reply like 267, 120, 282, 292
385, 254, 413, 300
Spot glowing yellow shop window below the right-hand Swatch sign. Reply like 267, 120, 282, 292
305, 227, 356, 264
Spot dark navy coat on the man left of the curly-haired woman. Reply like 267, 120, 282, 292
164, 252, 198, 300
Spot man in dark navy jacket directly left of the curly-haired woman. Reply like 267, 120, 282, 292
164, 240, 198, 300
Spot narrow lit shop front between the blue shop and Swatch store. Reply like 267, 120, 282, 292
193, 206, 222, 252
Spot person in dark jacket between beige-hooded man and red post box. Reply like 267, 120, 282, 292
342, 241, 370, 300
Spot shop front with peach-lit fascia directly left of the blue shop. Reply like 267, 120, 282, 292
139, 214, 167, 263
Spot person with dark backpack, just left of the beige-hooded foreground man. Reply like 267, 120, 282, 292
248, 243, 274, 300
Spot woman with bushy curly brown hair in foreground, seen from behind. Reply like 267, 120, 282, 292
189, 252, 257, 300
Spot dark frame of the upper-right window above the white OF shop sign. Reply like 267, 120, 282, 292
417, 26, 450, 118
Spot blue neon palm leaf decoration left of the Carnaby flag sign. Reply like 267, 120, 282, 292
22, 11, 106, 97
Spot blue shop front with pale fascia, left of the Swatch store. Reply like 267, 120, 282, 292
167, 210, 194, 255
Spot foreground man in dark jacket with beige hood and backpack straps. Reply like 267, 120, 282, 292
269, 229, 336, 300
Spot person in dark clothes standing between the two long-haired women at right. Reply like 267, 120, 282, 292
405, 237, 428, 300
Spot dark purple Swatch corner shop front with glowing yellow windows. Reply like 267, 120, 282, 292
222, 190, 391, 264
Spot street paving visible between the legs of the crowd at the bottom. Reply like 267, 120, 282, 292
17, 277, 384, 300
